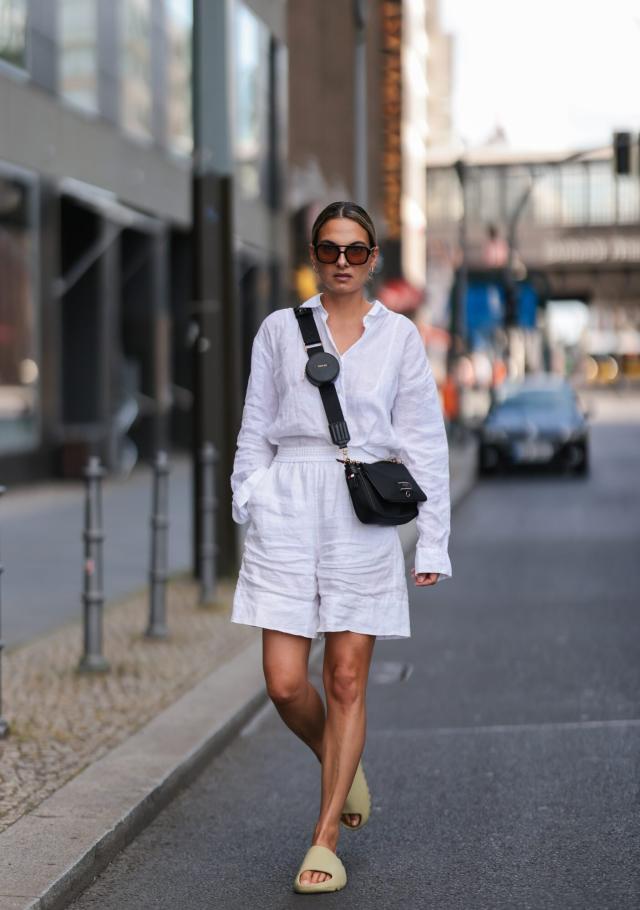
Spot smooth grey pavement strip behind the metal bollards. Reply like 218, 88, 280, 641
0, 454, 191, 647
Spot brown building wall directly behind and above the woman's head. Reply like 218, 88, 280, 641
288, 0, 386, 278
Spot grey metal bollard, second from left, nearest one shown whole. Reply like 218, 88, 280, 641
78, 455, 109, 673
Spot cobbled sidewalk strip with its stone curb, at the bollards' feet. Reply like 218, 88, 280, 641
0, 443, 475, 910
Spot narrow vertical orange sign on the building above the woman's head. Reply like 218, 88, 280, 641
382, 0, 402, 240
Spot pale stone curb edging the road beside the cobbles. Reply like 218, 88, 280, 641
0, 445, 475, 910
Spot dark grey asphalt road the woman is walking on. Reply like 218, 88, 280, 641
73, 392, 640, 910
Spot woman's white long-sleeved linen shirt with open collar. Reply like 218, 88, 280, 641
231, 294, 451, 580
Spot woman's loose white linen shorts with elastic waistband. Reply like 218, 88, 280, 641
231, 444, 411, 639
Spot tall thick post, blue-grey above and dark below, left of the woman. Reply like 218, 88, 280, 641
191, 0, 242, 581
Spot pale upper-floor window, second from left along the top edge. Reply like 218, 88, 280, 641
59, 0, 98, 111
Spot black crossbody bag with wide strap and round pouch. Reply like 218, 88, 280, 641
293, 306, 427, 525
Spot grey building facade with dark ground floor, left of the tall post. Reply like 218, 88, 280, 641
0, 0, 192, 482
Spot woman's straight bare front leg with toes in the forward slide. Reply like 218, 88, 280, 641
300, 632, 376, 883
